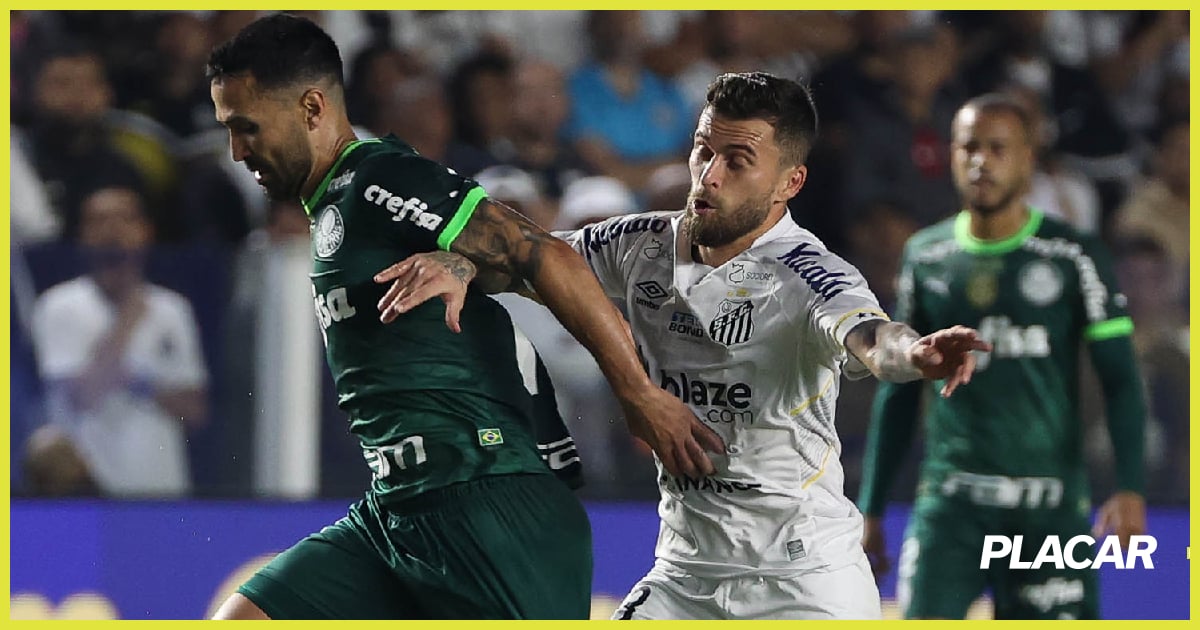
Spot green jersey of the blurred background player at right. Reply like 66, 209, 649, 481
875, 210, 1133, 487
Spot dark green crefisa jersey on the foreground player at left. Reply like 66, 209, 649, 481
304, 136, 580, 500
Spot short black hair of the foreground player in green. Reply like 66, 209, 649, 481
206, 13, 344, 90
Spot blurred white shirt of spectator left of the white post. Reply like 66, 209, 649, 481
32, 276, 208, 497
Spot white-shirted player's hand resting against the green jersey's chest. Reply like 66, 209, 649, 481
374, 252, 475, 332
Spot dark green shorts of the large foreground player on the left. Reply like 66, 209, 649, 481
238, 474, 592, 619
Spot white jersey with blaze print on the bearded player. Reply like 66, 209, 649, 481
558, 211, 887, 577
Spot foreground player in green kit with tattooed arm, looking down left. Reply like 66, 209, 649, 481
209, 14, 724, 619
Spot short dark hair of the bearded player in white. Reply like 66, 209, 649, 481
704, 72, 817, 164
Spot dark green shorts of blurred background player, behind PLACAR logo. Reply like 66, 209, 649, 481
896, 496, 1099, 619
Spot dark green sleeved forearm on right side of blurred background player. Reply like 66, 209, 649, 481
1090, 337, 1146, 494
